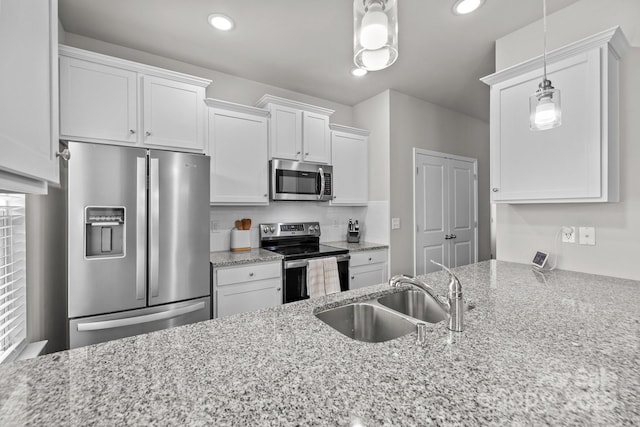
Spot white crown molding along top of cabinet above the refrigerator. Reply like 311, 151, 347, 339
58, 44, 211, 88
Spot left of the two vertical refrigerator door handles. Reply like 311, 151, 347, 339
136, 157, 147, 299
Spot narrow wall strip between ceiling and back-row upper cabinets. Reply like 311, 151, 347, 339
64, 33, 352, 126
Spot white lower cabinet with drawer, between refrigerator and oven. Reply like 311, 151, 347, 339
213, 261, 282, 317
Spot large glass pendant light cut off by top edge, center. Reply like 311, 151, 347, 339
353, 0, 398, 71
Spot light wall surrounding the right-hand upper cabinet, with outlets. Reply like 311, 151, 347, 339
496, 0, 640, 280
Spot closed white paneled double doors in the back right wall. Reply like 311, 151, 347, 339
414, 149, 477, 275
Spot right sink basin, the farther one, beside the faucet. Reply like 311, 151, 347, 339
378, 289, 448, 323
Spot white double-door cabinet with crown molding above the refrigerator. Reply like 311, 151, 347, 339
59, 46, 211, 153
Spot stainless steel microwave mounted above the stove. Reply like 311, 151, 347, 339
270, 159, 333, 201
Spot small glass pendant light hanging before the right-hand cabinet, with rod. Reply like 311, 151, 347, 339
529, 0, 562, 130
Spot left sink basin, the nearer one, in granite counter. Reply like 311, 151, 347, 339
316, 303, 416, 342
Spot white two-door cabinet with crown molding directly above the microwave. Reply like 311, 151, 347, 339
256, 95, 334, 164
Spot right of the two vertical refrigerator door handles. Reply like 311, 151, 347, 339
149, 158, 160, 297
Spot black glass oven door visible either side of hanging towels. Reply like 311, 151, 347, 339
282, 254, 351, 304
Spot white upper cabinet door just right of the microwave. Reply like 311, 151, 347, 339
331, 132, 369, 206
